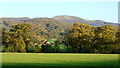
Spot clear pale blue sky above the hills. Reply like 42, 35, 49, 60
0, 1, 118, 23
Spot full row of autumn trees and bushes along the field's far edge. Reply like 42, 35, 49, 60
0, 23, 120, 53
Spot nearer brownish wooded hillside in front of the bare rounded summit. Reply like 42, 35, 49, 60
0, 17, 72, 38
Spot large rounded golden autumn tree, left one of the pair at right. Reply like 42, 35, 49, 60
65, 23, 94, 52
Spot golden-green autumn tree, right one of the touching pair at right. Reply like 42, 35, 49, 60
92, 25, 116, 51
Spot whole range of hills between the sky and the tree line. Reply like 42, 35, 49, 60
0, 16, 120, 38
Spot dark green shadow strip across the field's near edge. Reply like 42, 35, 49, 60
2, 61, 119, 68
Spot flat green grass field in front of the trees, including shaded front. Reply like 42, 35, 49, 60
2, 53, 118, 66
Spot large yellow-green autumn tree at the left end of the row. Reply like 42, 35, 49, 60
2, 23, 31, 52
